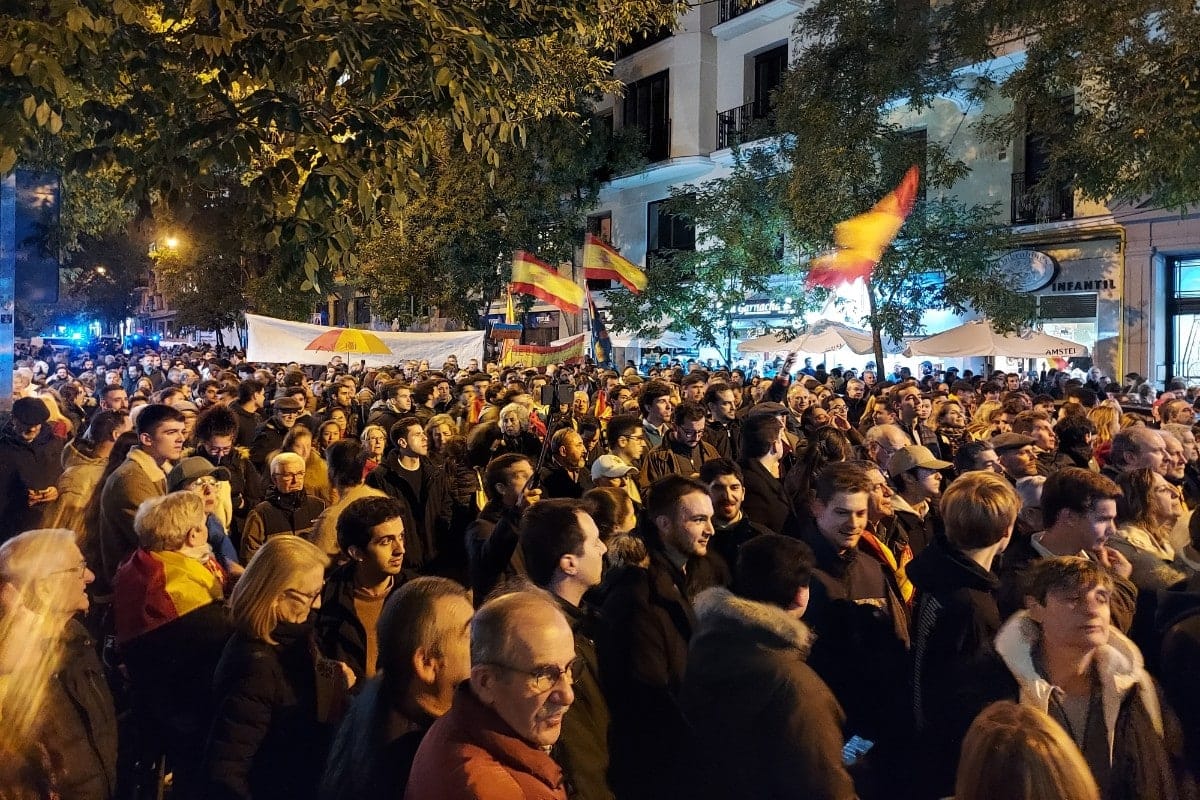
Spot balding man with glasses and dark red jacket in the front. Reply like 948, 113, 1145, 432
404, 593, 581, 800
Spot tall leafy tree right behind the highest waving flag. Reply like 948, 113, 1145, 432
776, 0, 1036, 365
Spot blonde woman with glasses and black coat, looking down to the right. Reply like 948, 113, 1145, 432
204, 536, 353, 800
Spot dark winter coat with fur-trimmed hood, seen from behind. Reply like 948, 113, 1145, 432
679, 588, 856, 800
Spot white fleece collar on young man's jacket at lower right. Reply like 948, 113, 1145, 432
996, 612, 1163, 752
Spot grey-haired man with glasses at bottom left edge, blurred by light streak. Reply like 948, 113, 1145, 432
0, 530, 116, 800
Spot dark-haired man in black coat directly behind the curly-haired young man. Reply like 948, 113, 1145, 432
366, 416, 451, 575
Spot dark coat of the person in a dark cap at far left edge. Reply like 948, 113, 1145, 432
0, 425, 62, 542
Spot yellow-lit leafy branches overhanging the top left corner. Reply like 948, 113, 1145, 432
0, 0, 685, 289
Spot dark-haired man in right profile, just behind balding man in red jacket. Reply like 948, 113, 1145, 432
520, 499, 613, 800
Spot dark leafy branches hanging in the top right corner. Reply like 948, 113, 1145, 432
934, 0, 1200, 207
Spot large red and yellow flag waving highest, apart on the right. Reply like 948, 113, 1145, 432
805, 167, 920, 289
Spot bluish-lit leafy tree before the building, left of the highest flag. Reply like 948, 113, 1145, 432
608, 144, 811, 361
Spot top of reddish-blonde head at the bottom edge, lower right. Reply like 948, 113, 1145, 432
954, 700, 1100, 800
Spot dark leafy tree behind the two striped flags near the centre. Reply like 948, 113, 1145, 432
347, 110, 637, 326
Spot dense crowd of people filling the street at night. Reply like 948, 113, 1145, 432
0, 350, 1200, 800
